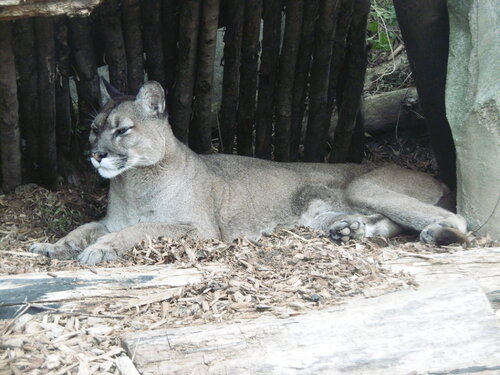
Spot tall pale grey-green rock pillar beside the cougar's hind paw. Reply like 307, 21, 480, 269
446, 0, 500, 239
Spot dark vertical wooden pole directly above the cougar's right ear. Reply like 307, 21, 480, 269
141, 0, 165, 87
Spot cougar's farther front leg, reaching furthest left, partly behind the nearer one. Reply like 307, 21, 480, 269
29, 221, 109, 259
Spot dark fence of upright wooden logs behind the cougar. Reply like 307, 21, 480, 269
0, 0, 370, 191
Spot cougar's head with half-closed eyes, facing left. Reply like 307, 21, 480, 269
90, 81, 167, 178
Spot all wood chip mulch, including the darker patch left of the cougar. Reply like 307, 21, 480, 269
0, 188, 494, 375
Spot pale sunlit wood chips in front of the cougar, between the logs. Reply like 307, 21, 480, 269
0, 228, 414, 374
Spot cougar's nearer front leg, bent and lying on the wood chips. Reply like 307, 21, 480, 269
78, 223, 202, 265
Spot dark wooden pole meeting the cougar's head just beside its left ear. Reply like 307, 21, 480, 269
99, 0, 128, 94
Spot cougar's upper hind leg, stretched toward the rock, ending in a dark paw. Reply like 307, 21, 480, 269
346, 179, 467, 245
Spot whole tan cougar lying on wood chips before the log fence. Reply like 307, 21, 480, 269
30, 81, 466, 264
